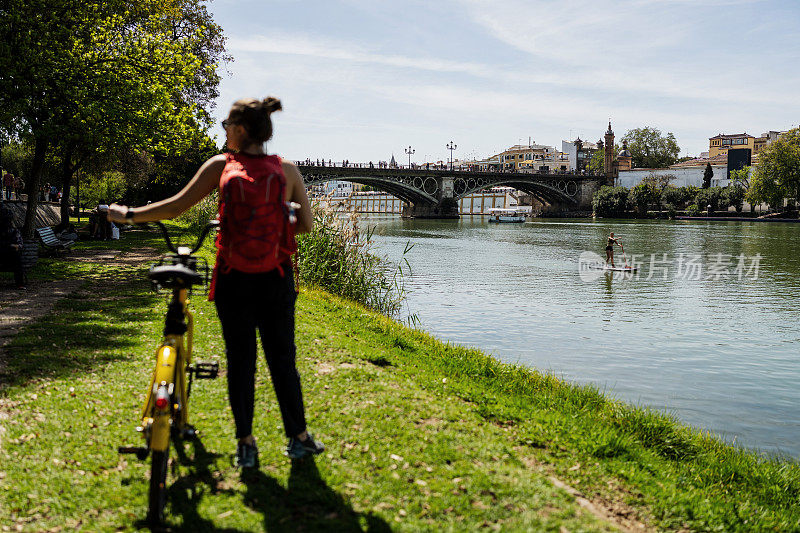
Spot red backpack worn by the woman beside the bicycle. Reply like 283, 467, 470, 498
216, 153, 297, 275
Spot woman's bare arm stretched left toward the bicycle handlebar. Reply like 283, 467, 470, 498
108, 154, 225, 223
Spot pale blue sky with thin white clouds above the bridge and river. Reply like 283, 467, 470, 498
210, 0, 800, 162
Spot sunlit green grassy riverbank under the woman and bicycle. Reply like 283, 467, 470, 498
0, 232, 800, 531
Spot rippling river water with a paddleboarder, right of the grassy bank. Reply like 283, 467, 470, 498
365, 217, 800, 458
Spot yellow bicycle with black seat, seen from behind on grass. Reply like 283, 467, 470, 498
119, 221, 219, 526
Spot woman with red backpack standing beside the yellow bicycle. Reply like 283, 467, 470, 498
108, 97, 325, 468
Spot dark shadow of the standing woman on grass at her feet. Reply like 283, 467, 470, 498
242, 457, 391, 532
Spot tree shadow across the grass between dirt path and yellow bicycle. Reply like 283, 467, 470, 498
0, 282, 156, 390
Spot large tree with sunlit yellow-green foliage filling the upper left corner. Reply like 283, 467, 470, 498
0, 0, 231, 238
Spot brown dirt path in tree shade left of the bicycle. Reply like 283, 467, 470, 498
0, 247, 159, 374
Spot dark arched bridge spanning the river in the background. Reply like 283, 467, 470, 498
298, 164, 608, 218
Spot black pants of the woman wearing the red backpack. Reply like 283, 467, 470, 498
214, 264, 306, 439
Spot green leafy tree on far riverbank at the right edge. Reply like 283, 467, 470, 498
748, 128, 800, 207
